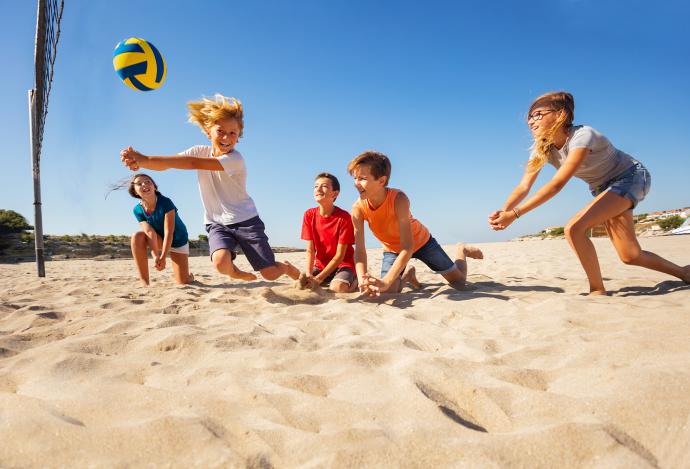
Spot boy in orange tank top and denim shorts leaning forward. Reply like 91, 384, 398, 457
347, 151, 484, 295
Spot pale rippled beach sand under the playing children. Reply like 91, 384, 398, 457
0, 236, 690, 468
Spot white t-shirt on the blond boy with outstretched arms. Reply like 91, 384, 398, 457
180, 145, 258, 225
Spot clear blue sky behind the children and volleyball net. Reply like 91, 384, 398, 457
0, 0, 690, 246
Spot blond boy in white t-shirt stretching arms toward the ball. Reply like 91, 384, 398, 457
120, 94, 299, 280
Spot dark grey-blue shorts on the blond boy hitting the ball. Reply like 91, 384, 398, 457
206, 215, 276, 270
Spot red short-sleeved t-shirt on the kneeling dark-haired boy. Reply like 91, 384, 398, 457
302, 207, 355, 270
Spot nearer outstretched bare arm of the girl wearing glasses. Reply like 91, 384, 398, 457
489, 148, 589, 230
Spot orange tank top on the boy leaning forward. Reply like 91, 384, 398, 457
357, 189, 431, 252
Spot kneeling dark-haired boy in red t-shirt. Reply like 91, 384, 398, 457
300, 173, 357, 293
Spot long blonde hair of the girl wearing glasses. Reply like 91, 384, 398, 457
527, 91, 575, 171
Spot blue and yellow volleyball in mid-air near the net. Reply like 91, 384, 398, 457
113, 37, 166, 91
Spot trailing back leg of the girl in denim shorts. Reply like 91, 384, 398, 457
604, 210, 690, 283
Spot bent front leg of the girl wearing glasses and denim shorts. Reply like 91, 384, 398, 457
565, 191, 632, 295
